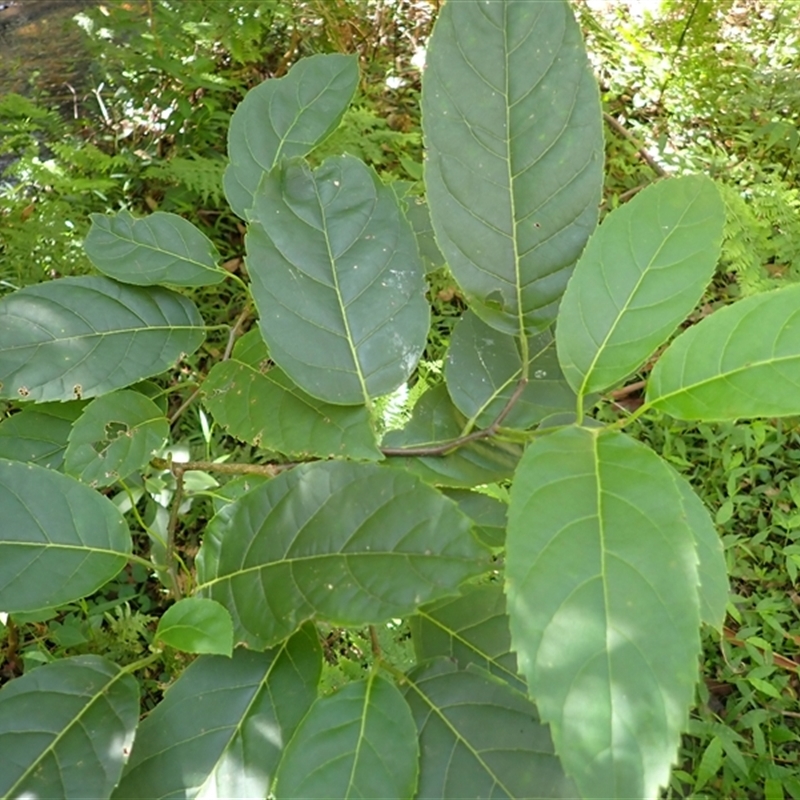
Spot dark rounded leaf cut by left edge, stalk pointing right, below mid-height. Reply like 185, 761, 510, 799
0, 459, 131, 612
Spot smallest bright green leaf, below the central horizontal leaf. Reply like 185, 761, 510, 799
156, 597, 233, 657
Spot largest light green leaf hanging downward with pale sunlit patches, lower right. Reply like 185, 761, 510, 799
506, 427, 700, 800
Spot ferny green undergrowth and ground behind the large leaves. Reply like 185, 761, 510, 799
0, 0, 800, 798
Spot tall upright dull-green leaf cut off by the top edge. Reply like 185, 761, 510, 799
422, 0, 603, 336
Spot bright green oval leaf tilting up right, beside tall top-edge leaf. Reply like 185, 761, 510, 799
556, 175, 725, 397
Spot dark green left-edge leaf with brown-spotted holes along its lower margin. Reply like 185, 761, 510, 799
0, 277, 204, 401
